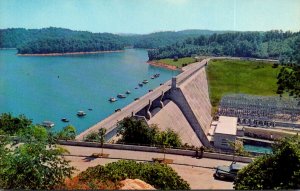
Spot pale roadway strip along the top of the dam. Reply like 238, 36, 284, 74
76, 59, 209, 140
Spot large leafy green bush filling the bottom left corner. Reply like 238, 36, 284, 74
0, 139, 74, 189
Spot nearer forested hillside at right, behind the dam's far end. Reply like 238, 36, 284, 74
148, 31, 300, 60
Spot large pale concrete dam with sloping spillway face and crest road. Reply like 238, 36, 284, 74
76, 59, 212, 147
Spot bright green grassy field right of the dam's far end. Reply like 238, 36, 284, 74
207, 60, 280, 110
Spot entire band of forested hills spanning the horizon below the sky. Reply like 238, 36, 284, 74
0, 27, 300, 57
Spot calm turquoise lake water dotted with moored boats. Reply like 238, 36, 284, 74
0, 49, 178, 133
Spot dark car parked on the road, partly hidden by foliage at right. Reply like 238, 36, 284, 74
214, 162, 244, 181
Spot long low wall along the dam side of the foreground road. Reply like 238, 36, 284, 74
59, 140, 253, 163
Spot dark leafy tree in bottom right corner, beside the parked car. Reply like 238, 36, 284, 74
234, 135, 300, 190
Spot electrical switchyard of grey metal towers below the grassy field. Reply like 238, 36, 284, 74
218, 94, 300, 128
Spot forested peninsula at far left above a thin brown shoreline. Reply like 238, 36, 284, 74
0, 27, 126, 54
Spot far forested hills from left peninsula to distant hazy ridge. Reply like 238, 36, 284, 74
0, 27, 222, 54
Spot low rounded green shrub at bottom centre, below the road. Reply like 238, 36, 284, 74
78, 160, 190, 190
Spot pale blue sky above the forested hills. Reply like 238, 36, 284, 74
0, 0, 300, 34
